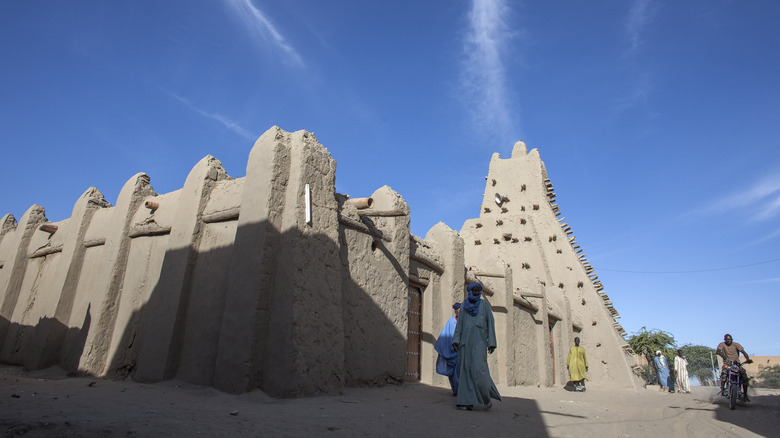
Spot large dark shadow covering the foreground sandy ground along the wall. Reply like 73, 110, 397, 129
0, 366, 555, 438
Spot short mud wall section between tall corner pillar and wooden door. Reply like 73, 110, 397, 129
340, 186, 410, 385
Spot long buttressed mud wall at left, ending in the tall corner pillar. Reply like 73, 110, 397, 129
0, 128, 376, 396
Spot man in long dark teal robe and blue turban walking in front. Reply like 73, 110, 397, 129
452, 283, 501, 410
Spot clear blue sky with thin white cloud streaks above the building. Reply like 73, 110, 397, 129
0, 0, 780, 355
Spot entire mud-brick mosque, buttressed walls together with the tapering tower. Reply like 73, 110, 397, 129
0, 127, 634, 397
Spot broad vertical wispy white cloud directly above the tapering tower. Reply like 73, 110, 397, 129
461, 0, 512, 139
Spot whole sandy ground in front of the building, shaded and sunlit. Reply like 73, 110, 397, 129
0, 366, 780, 438
